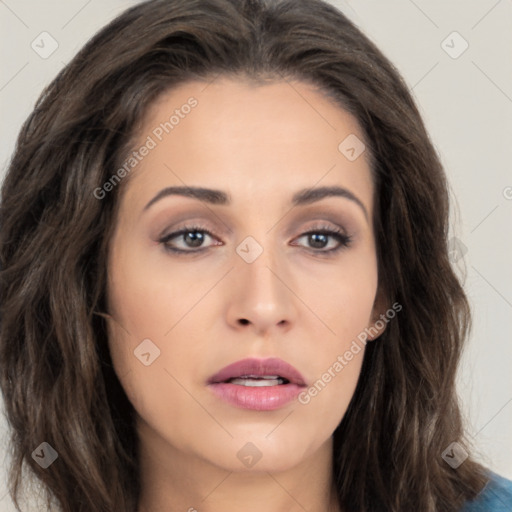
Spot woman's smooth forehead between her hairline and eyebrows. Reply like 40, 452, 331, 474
118, 78, 372, 214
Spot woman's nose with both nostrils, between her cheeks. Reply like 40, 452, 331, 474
227, 242, 297, 337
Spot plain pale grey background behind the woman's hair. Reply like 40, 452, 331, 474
0, 0, 512, 512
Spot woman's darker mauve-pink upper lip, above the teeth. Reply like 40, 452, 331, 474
208, 358, 306, 386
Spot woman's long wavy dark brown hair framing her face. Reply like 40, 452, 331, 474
0, 0, 486, 512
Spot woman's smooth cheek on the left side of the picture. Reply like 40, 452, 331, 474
104, 241, 217, 428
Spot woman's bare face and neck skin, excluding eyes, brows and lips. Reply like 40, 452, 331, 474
107, 78, 385, 512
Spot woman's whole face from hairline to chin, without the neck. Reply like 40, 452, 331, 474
108, 79, 383, 471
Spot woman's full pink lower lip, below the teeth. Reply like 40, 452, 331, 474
209, 382, 303, 411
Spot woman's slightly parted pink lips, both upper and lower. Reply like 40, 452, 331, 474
207, 358, 306, 411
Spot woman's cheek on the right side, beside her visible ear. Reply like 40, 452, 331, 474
292, 251, 378, 416
